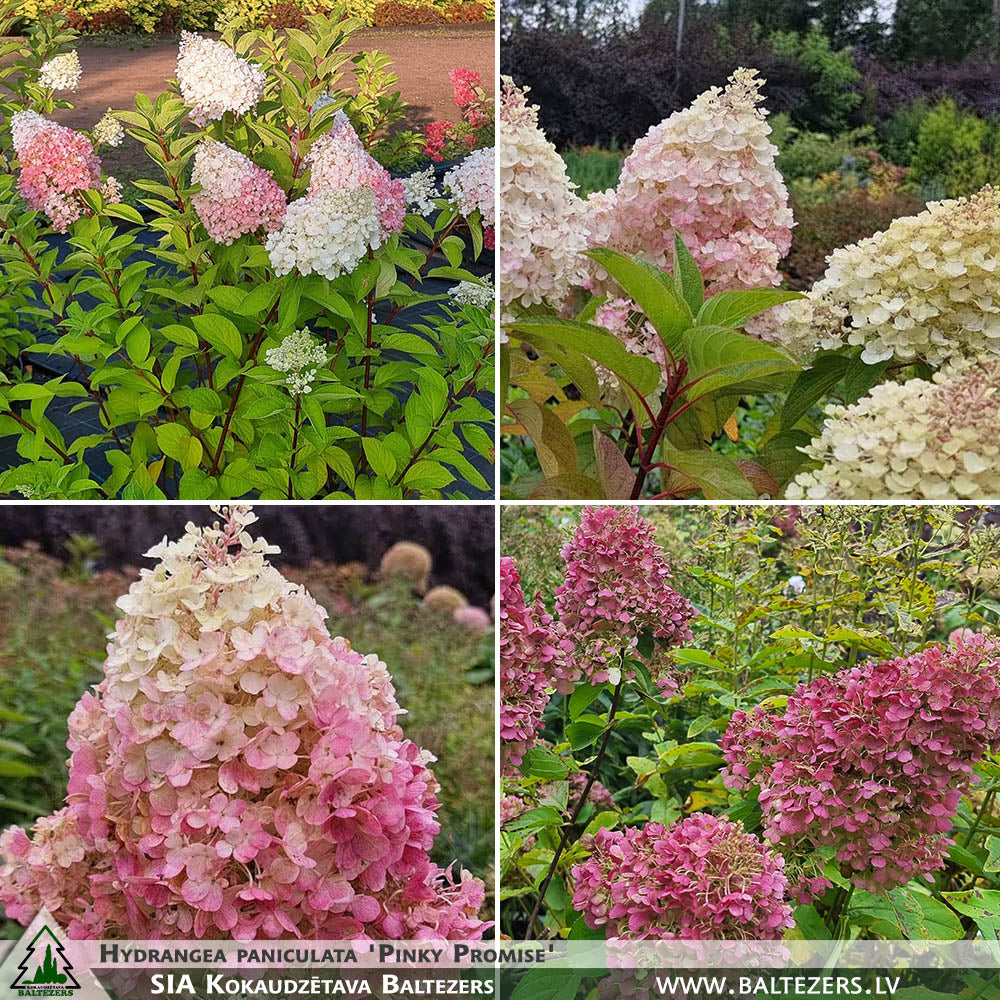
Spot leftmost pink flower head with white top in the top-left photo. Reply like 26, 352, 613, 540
11, 111, 101, 233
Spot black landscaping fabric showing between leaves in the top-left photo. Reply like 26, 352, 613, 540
0, 191, 495, 500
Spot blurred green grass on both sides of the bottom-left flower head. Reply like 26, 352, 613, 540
0, 552, 494, 938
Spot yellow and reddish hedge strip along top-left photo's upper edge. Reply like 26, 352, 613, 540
10, 0, 494, 34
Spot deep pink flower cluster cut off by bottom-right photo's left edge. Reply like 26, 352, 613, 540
499, 556, 579, 767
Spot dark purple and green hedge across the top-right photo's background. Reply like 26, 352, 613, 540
500, 18, 1000, 147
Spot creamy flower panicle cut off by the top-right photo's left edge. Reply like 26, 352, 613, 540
500, 77, 587, 316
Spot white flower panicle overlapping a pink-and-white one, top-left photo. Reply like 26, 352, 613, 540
265, 187, 381, 279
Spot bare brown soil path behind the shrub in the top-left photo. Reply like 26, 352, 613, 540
10, 24, 494, 172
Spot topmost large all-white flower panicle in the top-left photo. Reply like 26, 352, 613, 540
177, 31, 266, 126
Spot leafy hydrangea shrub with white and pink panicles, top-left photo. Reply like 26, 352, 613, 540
0, 0, 493, 499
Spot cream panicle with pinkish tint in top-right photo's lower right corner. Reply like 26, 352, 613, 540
787, 360, 1000, 500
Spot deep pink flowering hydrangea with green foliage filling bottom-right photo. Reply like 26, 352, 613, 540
508, 505, 1000, 940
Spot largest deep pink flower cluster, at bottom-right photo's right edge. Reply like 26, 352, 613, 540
722, 636, 1000, 892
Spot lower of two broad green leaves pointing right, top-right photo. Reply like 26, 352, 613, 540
684, 326, 800, 399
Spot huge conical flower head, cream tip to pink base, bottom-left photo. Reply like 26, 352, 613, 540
0, 508, 485, 939
